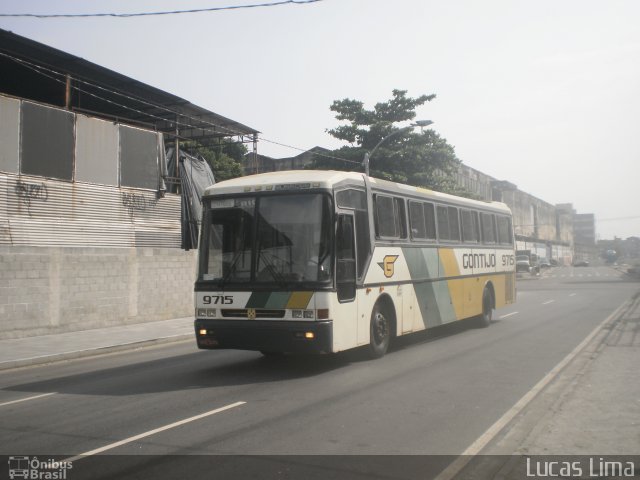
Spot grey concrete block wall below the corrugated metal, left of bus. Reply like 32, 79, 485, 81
0, 246, 196, 338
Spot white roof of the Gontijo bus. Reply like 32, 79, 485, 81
204, 170, 511, 213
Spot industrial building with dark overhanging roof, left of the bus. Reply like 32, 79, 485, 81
0, 30, 258, 338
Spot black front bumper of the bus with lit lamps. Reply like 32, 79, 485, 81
194, 319, 333, 353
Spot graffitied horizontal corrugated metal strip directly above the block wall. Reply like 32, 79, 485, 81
0, 174, 180, 248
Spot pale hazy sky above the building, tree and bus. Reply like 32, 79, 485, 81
0, 0, 640, 239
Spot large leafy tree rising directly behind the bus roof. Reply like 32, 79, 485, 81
312, 90, 461, 194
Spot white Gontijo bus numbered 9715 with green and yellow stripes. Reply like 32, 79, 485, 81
194, 170, 516, 358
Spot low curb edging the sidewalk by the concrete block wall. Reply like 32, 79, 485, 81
0, 333, 194, 371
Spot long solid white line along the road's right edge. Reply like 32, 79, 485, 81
435, 301, 629, 480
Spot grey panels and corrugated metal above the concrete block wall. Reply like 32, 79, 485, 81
0, 95, 181, 248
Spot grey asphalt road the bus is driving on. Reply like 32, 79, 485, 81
0, 267, 638, 479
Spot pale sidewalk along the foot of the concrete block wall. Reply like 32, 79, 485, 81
0, 317, 194, 370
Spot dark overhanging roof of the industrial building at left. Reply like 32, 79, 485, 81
0, 29, 258, 145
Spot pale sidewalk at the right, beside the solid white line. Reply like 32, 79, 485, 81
481, 292, 640, 455
